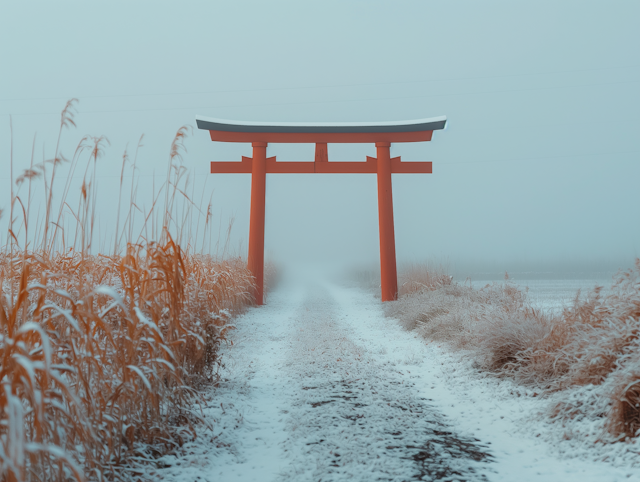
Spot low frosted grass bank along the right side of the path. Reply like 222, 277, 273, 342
386, 260, 640, 443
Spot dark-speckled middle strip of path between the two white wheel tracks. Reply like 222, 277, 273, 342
281, 287, 491, 481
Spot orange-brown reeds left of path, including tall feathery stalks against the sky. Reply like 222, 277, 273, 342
0, 101, 258, 481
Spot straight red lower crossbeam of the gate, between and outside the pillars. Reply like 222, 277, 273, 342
211, 156, 432, 174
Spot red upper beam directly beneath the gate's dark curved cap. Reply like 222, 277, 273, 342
209, 131, 433, 144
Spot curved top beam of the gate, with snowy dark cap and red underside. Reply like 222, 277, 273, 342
196, 116, 447, 144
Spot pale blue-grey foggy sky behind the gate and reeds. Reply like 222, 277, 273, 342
0, 0, 640, 276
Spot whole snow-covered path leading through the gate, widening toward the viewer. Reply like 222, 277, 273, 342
148, 276, 640, 482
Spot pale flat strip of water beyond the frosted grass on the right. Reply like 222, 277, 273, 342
467, 276, 613, 312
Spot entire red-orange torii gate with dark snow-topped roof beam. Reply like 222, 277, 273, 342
196, 116, 447, 305
